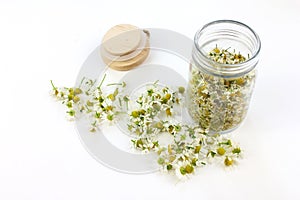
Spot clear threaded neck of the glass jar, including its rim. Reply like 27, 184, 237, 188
192, 20, 261, 78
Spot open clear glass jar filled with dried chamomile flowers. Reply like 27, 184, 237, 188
187, 20, 261, 133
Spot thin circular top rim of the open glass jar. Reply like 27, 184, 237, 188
194, 19, 261, 67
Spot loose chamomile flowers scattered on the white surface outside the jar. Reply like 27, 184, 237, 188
51, 76, 243, 180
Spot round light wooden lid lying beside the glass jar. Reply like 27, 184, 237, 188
101, 24, 149, 71
